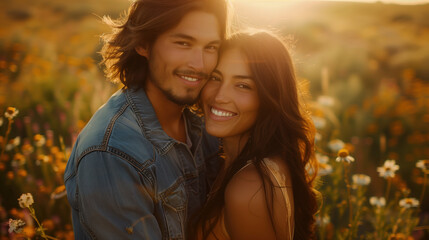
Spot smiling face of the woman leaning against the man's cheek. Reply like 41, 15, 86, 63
201, 49, 259, 138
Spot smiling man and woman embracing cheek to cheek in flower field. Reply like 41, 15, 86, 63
64, 0, 317, 239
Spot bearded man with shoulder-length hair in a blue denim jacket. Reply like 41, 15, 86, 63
64, 0, 227, 239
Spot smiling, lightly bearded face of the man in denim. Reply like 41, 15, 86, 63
136, 11, 221, 105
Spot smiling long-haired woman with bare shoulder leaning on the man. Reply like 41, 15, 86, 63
190, 31, 317, 240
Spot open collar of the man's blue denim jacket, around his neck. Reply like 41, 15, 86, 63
123, 88, 202, 154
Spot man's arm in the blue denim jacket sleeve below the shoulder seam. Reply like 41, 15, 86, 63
76, 152, 162, 239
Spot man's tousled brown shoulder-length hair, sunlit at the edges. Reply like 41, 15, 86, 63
100, 0, 230, 88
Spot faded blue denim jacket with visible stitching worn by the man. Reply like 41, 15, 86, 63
64, 89, 218, 240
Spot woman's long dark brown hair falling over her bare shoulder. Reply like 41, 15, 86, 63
189, 31, 317, 240
